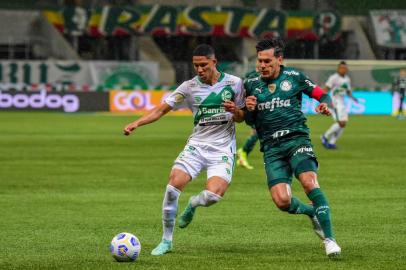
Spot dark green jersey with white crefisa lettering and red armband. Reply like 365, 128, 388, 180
244, 66, 331, 148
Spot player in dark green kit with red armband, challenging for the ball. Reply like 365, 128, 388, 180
226, 39, 341, 257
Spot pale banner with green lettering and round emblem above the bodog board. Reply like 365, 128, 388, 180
0, 60, 159, 91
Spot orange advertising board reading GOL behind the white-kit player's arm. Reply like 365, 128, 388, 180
110, 90, 191, 115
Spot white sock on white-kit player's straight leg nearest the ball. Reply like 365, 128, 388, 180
162, 185, 180, 241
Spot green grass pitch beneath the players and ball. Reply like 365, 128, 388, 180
0, 112, 406, 270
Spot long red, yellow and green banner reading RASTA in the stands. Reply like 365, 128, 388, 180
44, 4, 341, 39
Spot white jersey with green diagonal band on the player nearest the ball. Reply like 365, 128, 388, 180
165, 73, 244, 153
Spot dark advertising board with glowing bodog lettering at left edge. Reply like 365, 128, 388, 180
0, 89, 109, 113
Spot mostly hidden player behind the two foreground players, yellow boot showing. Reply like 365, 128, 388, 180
237, 69, 260, 170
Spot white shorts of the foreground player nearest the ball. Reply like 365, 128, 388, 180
172, 144, 235, 183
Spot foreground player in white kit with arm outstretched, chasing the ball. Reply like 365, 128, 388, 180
124, 44, 244, 256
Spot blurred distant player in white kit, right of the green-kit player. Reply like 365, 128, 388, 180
321, 61, 358, 149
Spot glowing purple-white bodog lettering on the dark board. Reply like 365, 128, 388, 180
0, 90, 80, 112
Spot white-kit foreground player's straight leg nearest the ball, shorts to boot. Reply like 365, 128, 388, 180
151, 145, 203, 255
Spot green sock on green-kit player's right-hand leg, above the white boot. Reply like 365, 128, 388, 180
307, 188, 334, 239
